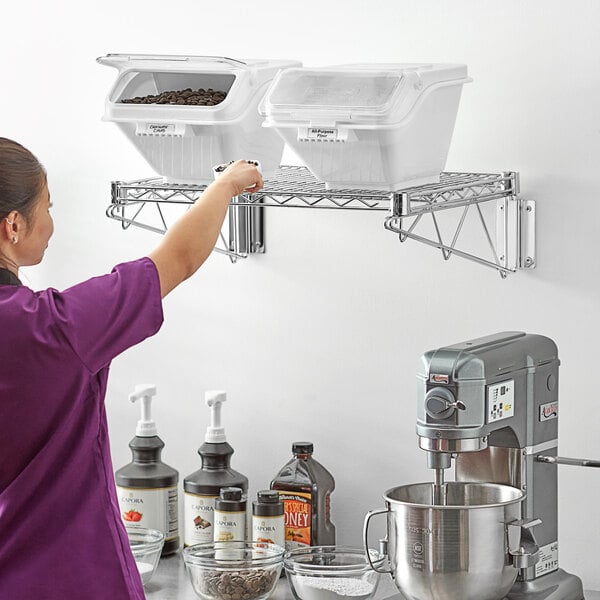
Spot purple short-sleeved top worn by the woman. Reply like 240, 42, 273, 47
0, 258, 163, 600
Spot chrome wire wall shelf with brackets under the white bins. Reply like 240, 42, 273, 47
106, 166, 535, 277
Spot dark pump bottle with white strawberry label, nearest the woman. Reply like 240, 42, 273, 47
115, 384, 179, 556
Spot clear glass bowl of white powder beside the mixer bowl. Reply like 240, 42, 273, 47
283, 546, 383, 600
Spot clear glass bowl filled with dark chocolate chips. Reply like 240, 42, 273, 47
183, 541, 285, 600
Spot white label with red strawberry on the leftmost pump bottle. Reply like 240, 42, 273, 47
117, 486, 179, 542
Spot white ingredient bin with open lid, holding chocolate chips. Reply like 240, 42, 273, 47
97, 54, 301, 183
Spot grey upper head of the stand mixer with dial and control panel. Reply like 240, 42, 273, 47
416, 332, 558, 476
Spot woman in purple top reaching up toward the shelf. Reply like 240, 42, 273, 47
0, 138, 262, 600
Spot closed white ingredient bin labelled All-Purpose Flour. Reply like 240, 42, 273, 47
260, 64, 471, 191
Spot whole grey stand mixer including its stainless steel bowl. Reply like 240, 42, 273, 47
363, 332, 600, 600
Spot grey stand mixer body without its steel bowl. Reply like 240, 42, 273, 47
417, 332, 600, 600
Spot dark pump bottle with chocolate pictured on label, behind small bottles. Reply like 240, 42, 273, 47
183, 391, 248, 546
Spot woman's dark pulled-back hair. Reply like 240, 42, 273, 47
0, 137, 46, 222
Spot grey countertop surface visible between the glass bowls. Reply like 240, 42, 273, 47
145, 553, 600, 600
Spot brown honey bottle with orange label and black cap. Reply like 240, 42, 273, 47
271, 442, 335, 550
